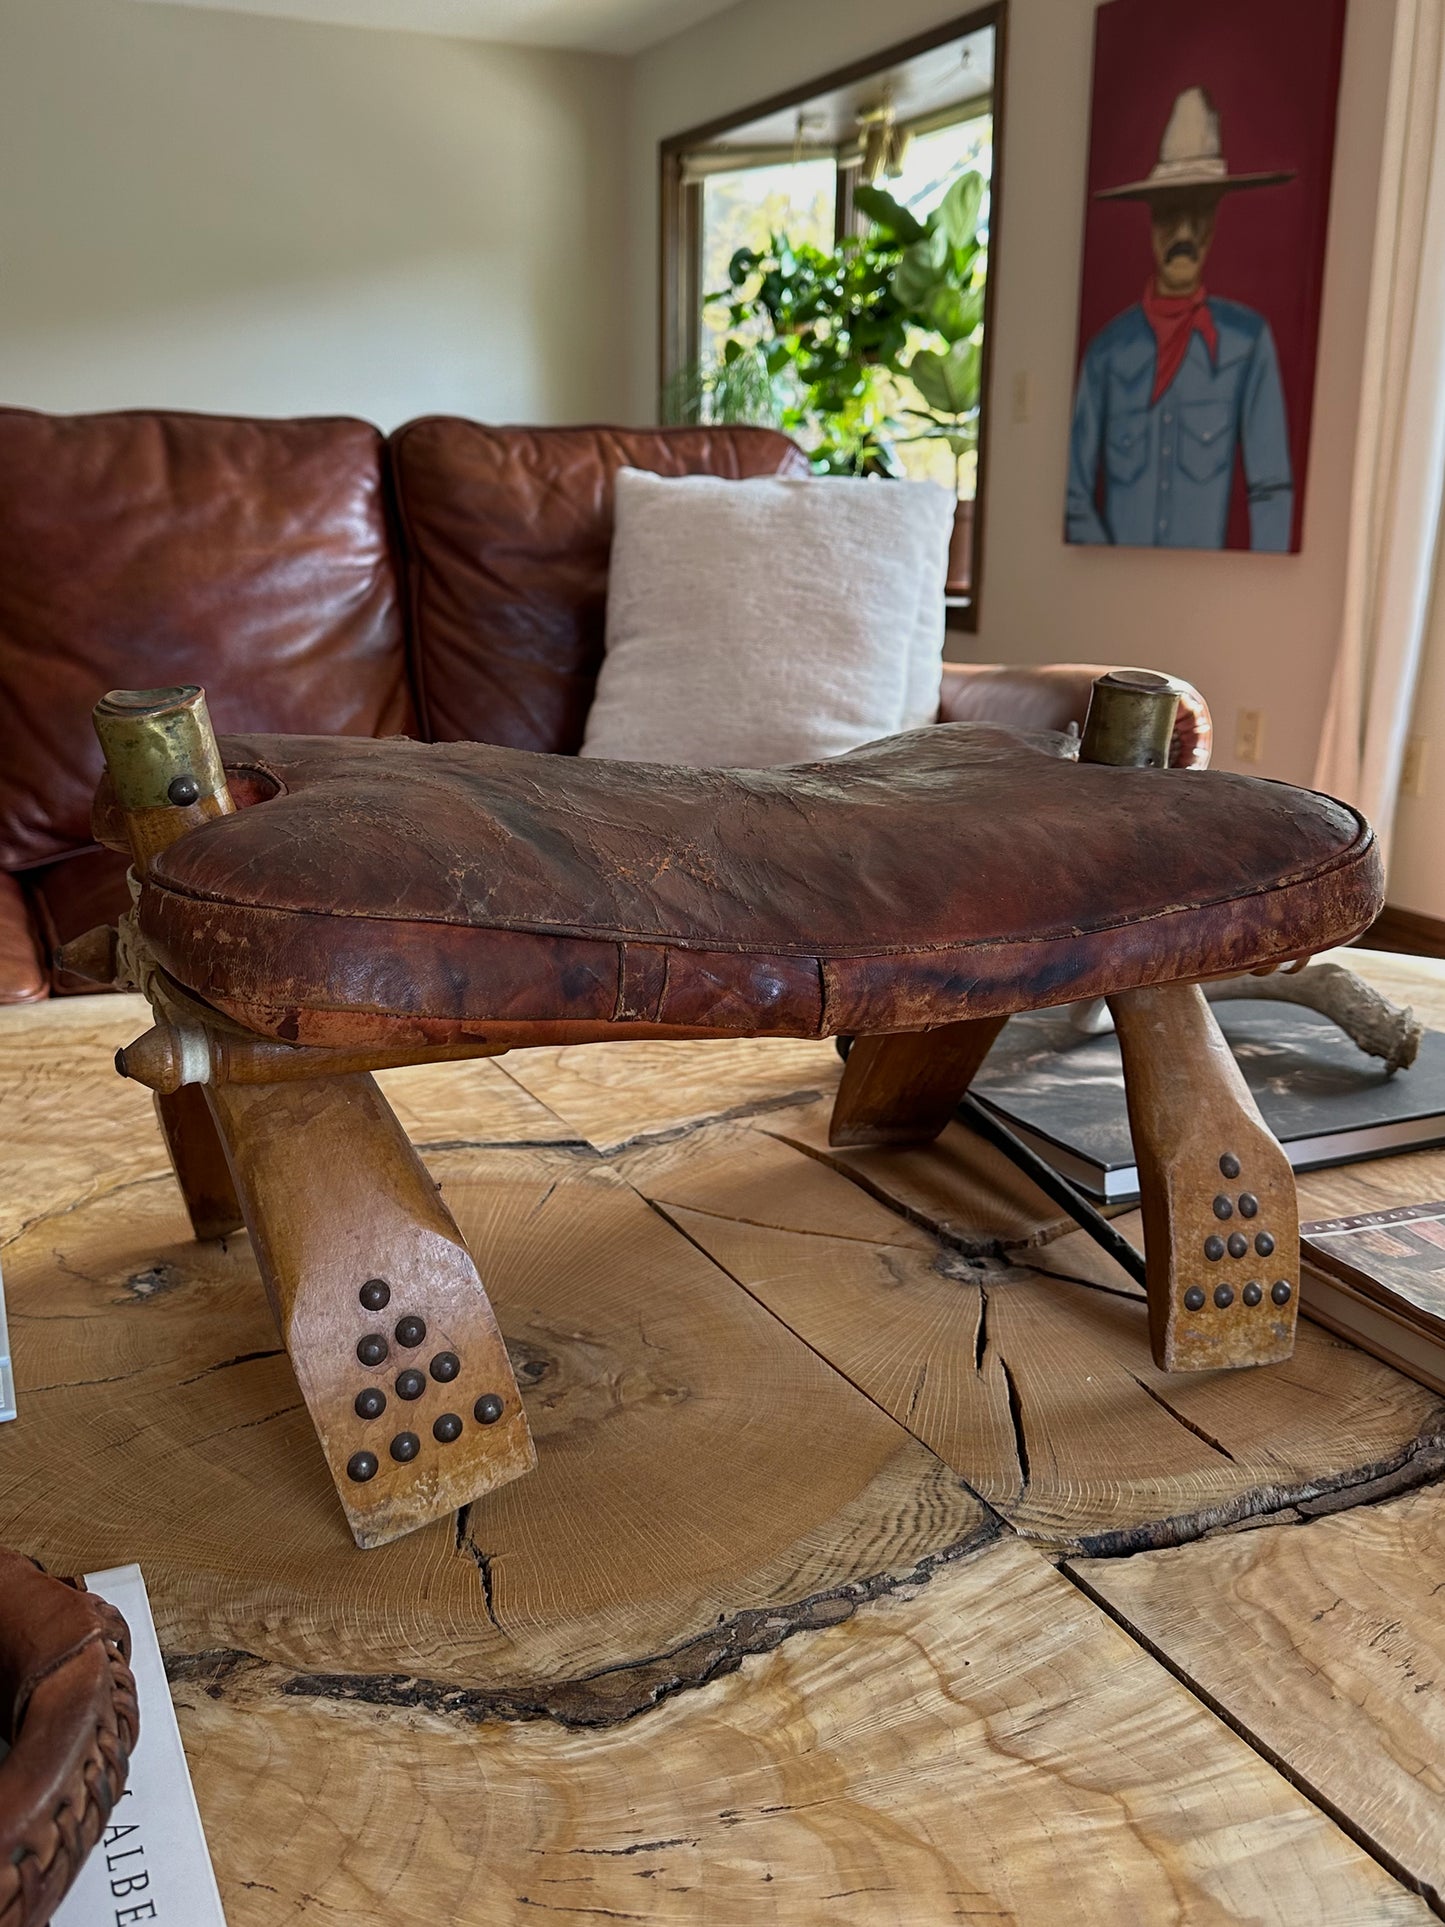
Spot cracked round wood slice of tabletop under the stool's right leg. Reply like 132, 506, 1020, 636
618, 1120, 1445, 1551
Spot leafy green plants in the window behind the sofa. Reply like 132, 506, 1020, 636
693, 172, 988, 493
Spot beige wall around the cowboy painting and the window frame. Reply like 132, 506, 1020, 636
630, 0, 1395, 780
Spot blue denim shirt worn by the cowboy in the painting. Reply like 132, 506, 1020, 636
1065, 297, 1295, 551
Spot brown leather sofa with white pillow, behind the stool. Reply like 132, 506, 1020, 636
0, 409, 1208, 1004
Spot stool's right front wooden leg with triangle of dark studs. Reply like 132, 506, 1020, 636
1108, 985, 1299, 1372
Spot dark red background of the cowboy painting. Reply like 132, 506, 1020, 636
1079, 0, 1345, 549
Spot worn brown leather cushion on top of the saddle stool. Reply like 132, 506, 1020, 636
141, 723, 1379, 1044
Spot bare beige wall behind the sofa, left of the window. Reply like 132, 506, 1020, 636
0, 0, 626, 426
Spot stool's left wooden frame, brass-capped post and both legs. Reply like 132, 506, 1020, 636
94, 684, 536, 1545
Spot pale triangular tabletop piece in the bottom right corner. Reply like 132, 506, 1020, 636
1069, 1486, 1445, 1912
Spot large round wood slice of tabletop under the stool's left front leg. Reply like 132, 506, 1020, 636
0, 1125, 988, 1717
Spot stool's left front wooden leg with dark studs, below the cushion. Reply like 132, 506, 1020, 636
204, 1073, 536, 1545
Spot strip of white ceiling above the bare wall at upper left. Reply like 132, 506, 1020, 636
132, 0, 747, 54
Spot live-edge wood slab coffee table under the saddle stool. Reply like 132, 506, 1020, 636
0, 952, 1445, 1927
